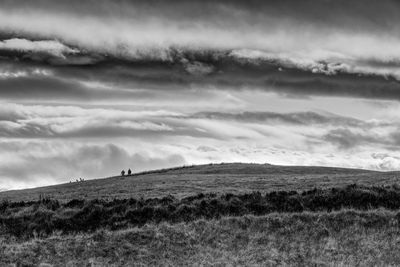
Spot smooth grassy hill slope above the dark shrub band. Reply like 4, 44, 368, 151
0, 163, 400, 201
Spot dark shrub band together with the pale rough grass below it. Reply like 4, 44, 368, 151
0, 185, 400, 266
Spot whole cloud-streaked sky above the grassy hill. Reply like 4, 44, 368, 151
0, 0, 400, 190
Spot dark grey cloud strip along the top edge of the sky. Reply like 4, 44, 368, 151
1, 0, 399, 30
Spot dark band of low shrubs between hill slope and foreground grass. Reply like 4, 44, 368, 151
0, 185, 400, 238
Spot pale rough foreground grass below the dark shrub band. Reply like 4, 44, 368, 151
0, 210, 400, 266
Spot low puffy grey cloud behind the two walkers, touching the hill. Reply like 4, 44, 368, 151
0, 143, 186, 186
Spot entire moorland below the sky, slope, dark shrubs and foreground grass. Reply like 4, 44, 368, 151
0, 164, 400, 267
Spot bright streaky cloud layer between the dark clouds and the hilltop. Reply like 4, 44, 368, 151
0, 99, 400, 191
